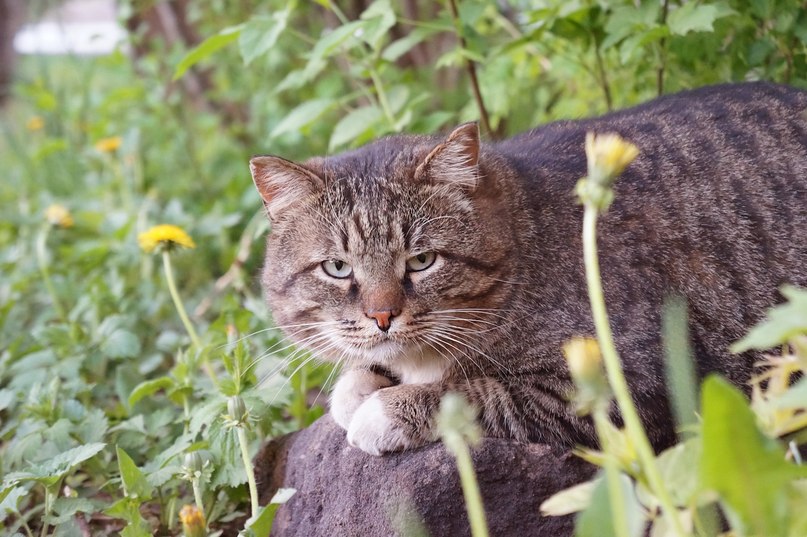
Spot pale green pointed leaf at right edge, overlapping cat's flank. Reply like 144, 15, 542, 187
731, 285, 807, 352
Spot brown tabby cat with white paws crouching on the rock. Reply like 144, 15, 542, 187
250, 83, 807, 455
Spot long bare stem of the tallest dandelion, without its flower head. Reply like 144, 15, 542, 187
583, 202, 686, 537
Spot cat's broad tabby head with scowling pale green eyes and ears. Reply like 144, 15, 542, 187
250, 123, 515, 365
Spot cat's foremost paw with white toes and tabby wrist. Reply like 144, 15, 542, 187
347, 384, 444, 455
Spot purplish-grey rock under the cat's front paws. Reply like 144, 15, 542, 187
255, 416, 594, 537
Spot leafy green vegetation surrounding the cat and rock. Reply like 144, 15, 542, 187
0, 0, 807, 536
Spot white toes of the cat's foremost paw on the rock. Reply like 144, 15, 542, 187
347, 393, 412, 455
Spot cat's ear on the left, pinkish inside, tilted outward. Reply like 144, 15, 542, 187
249, 157, 325, 220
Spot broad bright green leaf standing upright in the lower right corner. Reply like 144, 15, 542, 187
700, 376, 807, 535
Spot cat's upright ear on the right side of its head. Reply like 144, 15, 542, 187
415, 122, 479, 191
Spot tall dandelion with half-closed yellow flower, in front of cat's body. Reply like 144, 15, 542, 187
576, 133, 685, 536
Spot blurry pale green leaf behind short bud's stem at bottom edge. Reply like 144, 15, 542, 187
574, 473, 645, 537
